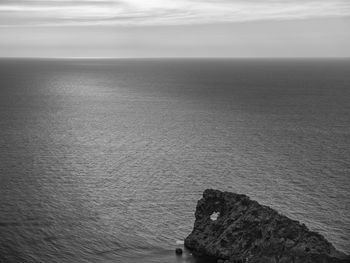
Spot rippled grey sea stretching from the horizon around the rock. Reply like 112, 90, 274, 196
0, 59, 350, 263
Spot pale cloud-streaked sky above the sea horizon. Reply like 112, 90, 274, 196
0, 0, 350, 58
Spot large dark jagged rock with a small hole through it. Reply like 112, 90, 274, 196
185, 189, 350, 263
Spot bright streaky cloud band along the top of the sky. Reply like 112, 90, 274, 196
0, 0, 350, 27
